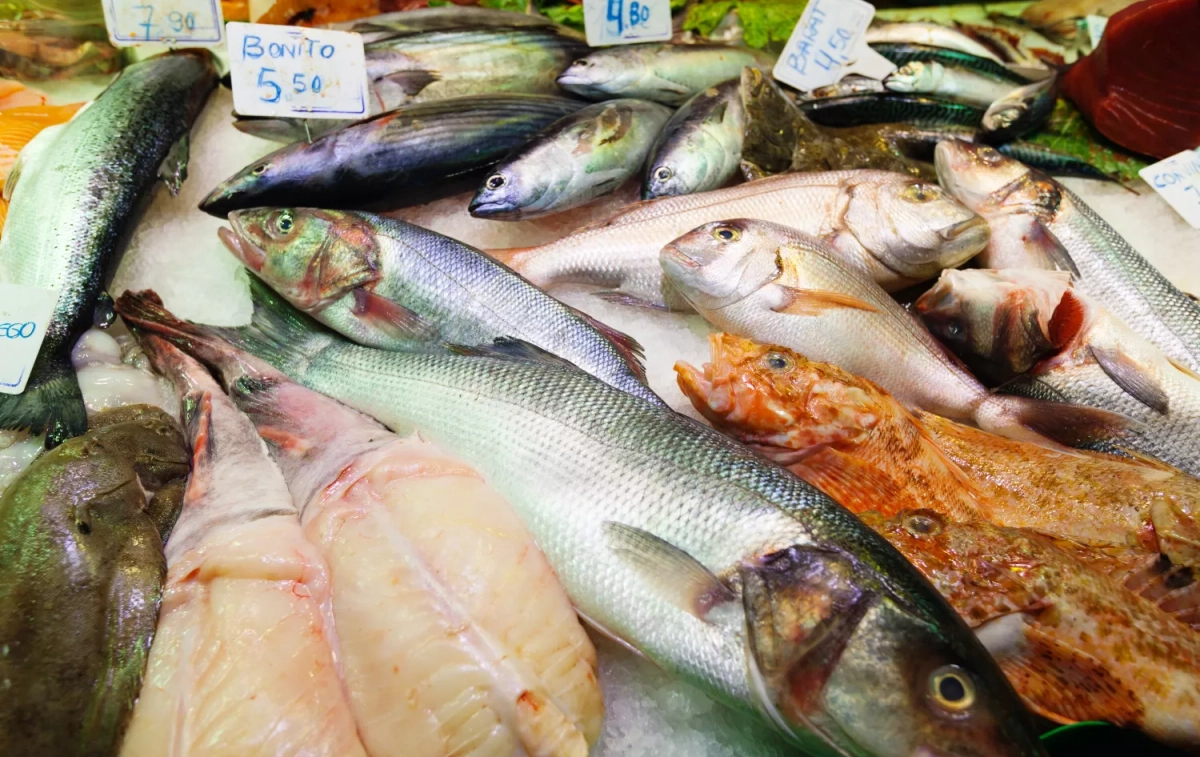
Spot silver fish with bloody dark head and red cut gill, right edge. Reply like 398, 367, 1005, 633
917, 271, 1200, 475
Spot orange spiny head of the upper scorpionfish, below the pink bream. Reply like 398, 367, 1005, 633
676, 334, 881, 462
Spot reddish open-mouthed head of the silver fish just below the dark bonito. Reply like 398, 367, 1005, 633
221, 208, 380, 312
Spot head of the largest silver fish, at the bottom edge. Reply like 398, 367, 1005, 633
738, 539, 1044, 757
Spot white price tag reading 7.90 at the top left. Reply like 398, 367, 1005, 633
103, 0, 224, 47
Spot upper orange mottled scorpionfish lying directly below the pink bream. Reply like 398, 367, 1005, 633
676, 334, 1200, 569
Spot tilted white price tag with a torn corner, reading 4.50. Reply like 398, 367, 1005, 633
772, 0, 896, 92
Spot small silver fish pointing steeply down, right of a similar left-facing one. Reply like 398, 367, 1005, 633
642, 79, 746, 200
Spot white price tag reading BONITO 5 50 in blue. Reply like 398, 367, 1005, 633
227, 22, 368, 119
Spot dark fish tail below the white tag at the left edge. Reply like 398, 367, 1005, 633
0, 349, 88, 449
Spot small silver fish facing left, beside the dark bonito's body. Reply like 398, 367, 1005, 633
468, 98, 671, 221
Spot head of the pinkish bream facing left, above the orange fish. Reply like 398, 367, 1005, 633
659, 218, 784, 311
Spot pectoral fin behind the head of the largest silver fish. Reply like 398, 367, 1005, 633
602, 521, 737, 619
